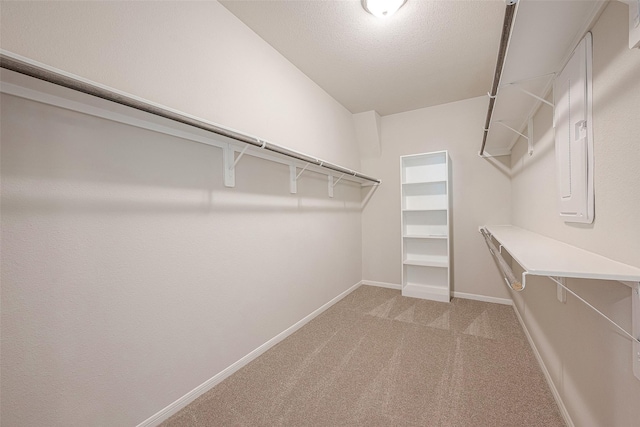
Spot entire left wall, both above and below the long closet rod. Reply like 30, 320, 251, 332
0, 2, 361, 426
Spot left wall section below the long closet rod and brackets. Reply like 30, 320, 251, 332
1, 85, 361, 426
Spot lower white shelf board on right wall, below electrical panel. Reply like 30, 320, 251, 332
485, 225, 640, 282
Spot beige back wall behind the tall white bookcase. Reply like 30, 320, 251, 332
362, 97, 511, 298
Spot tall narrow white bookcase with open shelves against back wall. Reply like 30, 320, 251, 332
400, 151, 451, 302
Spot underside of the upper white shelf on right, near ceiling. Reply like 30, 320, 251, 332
480, 0, 606, 157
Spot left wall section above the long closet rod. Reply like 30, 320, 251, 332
0, 1, 359, 169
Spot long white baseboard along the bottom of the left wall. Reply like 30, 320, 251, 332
137, 281, 362, 427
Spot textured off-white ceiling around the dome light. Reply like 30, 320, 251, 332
221, 0, 505, 116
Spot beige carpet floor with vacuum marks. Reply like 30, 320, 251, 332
162, 286, 565, 427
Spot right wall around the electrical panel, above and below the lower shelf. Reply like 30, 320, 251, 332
512, 2, 640, 426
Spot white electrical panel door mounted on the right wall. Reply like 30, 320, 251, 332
553, 33, 594, 223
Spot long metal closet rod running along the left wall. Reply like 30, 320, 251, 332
0, 52, 381, 184
